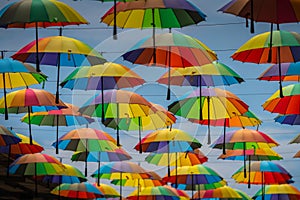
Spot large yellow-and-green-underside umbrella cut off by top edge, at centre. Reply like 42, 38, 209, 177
101, 0, 206, 40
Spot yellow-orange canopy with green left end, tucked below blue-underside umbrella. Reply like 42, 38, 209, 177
145, 149, 208, 167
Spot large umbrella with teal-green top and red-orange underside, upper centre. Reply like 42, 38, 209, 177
123, 33, 217, 100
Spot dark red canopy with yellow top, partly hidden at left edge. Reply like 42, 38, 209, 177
0, 133, 44, 155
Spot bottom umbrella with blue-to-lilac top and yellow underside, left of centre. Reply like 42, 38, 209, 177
92, 161, 151, 199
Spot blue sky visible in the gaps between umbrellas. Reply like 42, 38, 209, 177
0, 0, 300, 198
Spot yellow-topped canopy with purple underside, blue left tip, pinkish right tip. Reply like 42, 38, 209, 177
60, 62, 145, 90
